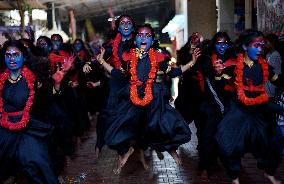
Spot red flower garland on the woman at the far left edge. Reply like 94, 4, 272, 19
0, 66, 35, 131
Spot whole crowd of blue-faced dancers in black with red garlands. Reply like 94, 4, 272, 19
0, 15, 284, 184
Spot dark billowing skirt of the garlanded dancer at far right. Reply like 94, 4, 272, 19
216, 100, 281, 161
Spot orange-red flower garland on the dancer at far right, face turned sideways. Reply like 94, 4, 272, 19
235, 54, 269, 105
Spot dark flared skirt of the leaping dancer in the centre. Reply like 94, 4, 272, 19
105, 83, 191, 154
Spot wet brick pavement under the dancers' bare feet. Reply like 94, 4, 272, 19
62, 118, 284, 184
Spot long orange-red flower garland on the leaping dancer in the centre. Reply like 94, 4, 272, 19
130, 48, 157, 106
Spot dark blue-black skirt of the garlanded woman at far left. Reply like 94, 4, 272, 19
0, 118, 58, 184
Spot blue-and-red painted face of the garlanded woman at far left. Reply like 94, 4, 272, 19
5, 47, 24, 71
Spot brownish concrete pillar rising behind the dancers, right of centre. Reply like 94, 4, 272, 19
188, 0, 217, 39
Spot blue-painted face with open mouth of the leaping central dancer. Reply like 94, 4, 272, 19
135, 27, 153, 52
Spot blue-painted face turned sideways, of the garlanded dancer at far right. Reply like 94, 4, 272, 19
246, 37, 265, 61
